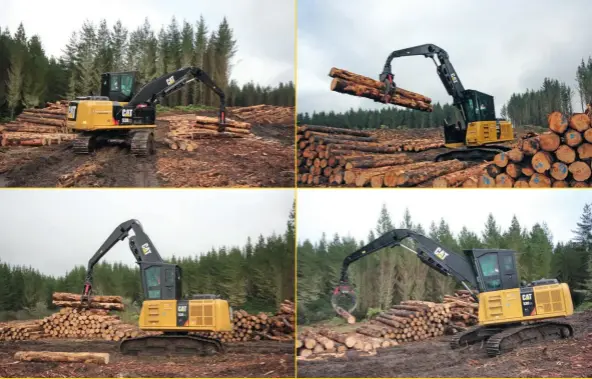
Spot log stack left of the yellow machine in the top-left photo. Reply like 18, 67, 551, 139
0, 101, 75, 146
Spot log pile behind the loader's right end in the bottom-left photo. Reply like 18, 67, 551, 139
197, 300, 296, 343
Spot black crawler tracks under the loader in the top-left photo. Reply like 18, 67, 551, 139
73, 129, 156, 157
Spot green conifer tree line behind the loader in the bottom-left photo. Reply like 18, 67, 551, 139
0, 203, 295, 318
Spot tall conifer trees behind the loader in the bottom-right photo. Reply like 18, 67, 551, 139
297, 204, 592, 325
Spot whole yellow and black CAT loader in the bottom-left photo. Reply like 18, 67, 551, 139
81, 219, 232, 355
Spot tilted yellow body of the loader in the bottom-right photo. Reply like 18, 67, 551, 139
479, 283, 573, 325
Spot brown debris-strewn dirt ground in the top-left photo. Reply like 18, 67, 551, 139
0, 113, 294, 187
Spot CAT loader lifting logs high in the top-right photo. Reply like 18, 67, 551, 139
379, 44, 515, 161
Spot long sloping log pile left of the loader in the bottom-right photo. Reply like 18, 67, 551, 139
297, 291, 478, 358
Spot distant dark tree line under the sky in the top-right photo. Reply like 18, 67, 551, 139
298, 57, 592, 129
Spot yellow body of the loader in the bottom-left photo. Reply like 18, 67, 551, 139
139, 299, 232, 332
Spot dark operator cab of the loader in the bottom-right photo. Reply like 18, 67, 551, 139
464, 249, 520, 292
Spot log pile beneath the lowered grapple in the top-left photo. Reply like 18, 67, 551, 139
159, 115, 252, 151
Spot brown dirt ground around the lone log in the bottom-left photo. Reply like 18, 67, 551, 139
0, 340, 294, 378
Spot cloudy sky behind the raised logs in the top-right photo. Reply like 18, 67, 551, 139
297, 0, 592, 114
